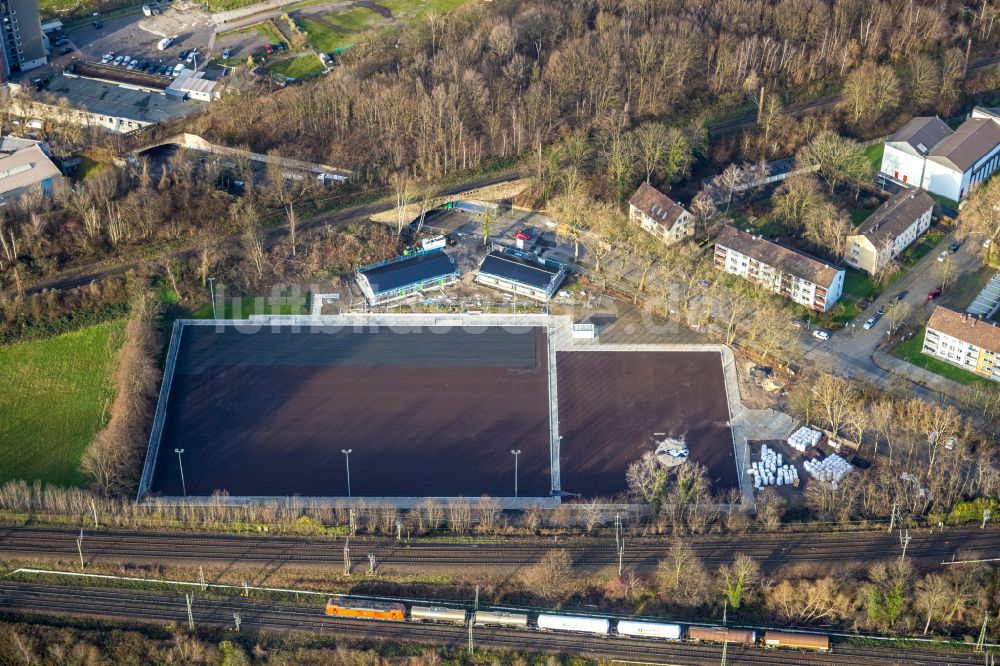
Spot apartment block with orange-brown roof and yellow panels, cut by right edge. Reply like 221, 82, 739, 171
921, 305, 1000, 382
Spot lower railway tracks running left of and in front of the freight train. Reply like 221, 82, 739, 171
0, 582, 983, 666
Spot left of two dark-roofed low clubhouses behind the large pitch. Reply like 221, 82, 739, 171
356, 250, 460, 305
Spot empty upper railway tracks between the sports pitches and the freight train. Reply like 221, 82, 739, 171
0, 527, 1000, 568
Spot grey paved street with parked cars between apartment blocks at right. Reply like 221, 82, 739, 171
803, 232, 981, 397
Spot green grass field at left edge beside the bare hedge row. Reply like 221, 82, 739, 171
0, 319, 125, 486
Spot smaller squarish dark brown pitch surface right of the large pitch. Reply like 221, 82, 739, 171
556, 351, 737, 497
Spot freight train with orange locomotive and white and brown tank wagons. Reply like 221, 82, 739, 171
326, 597, 830, 652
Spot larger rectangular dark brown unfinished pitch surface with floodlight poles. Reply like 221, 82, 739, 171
152, 326, 550, 497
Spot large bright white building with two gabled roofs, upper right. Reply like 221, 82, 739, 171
880, 113, 1000, 201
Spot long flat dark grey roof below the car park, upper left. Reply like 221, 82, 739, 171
39, 76, 205, 123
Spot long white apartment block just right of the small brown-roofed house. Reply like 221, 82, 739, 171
715, 225, 845, 312
